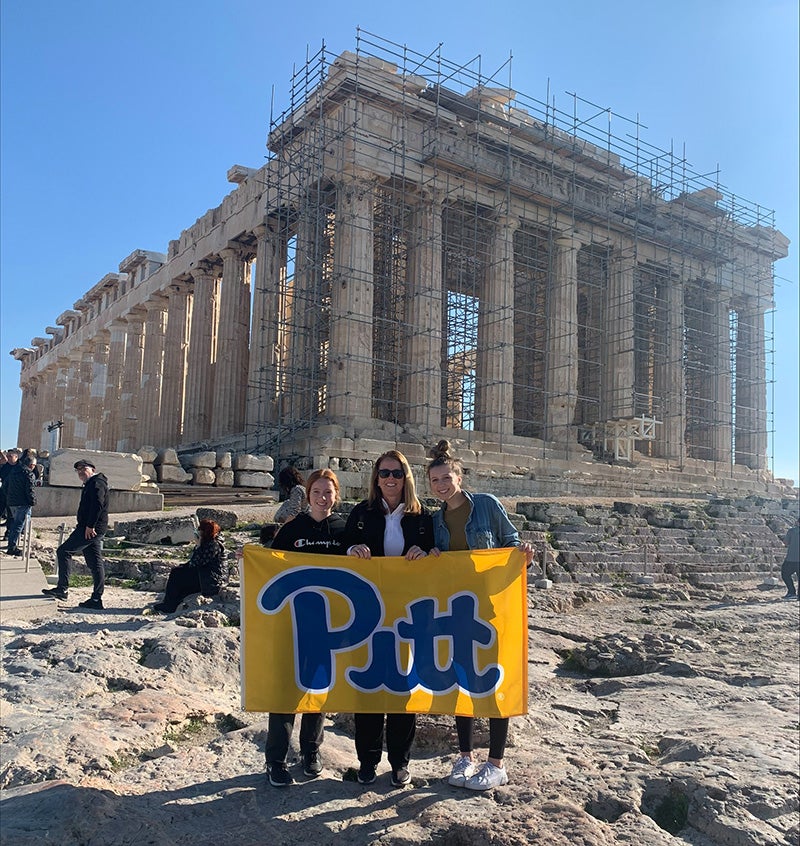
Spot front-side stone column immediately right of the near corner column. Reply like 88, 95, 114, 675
401, 192, 443, 434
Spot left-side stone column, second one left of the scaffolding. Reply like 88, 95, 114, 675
182, 262, 217, 443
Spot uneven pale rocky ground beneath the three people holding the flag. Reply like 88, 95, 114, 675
0, 515, 800, 846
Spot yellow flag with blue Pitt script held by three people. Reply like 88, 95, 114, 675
241, 545, 528, 717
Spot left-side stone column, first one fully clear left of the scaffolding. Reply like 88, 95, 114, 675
211, 244, 250, 438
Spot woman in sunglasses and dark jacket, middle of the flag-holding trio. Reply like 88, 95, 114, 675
345, 449, 433, 787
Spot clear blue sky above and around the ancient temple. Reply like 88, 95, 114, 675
0, 0, 800, 486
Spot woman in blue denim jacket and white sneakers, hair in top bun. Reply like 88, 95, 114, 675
428, 441, 533, 790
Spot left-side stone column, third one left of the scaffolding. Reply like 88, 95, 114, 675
159, 282, 189, 447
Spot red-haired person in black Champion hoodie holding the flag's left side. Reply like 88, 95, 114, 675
265, 469, 345, 787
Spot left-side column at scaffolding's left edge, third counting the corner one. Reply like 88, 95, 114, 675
247, 221, 286, 431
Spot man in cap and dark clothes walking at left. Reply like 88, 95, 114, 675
42, 458, 108, 611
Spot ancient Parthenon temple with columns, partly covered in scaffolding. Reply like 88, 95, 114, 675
12, 31, 788, 500
